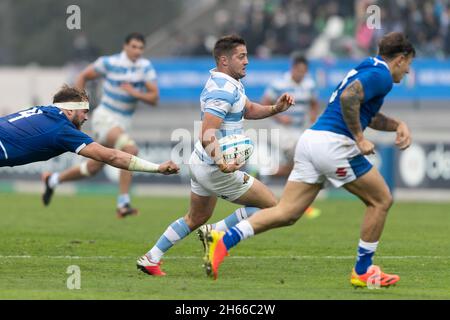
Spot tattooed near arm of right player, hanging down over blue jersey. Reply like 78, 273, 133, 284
340, 80, 375, 155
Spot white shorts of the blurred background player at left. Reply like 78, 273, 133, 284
92, 104, 132, 144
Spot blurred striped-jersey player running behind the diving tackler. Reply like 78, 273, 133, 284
42, 33, 159, 218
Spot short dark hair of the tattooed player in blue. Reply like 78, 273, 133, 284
378, 32, 416, 59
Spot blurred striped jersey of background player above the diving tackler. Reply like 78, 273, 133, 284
94, 51, 156, 116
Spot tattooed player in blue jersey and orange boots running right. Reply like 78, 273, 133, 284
205, 32, 415, 287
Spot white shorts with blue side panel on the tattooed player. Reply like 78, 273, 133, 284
289, 129, 372, 188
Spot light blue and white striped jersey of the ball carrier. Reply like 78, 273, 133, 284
195, 69, 247, 163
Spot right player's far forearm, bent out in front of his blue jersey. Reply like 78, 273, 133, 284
369, 113, 411, 150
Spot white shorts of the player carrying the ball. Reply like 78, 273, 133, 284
189, 150, 255, 201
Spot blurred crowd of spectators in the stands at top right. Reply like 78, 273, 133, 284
173, 0, 450, 58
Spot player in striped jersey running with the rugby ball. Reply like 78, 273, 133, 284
137, 35, 294, 276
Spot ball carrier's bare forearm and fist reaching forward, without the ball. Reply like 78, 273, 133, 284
244, 93, 295, 120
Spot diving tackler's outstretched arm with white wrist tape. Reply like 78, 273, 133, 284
79, 142, 180, 175
